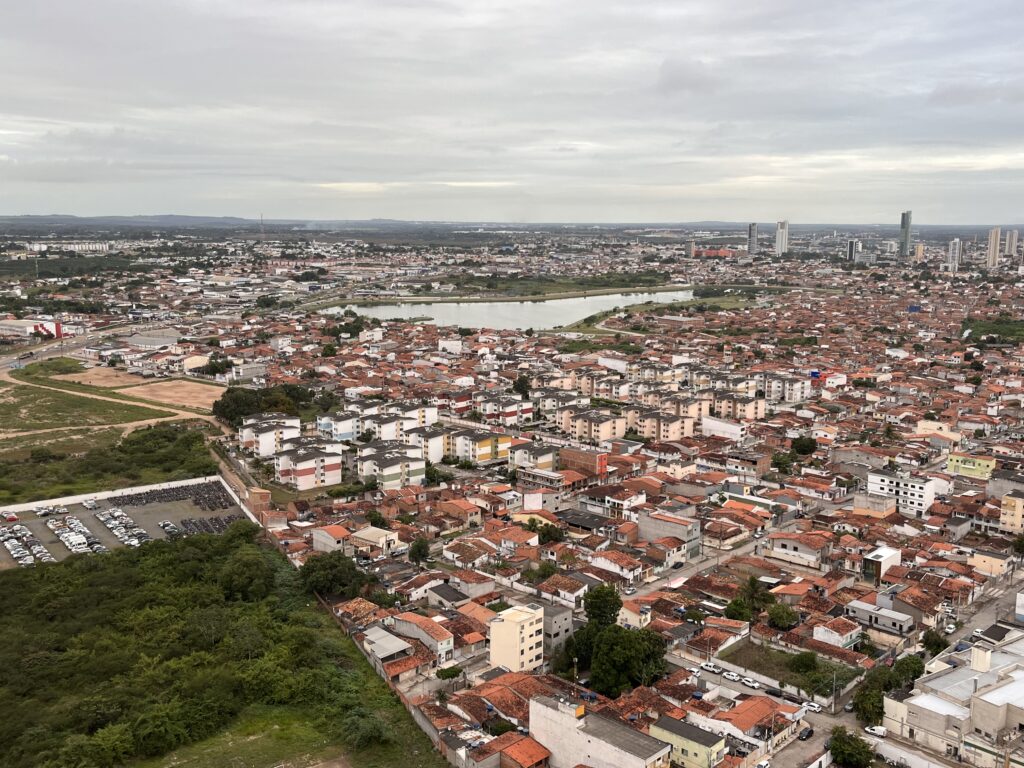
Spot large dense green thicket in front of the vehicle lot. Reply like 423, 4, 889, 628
0, 522, 437, 768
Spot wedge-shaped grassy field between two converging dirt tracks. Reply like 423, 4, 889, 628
0, 385, 171, 432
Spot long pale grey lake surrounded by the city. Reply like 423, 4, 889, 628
325, 289, 693, 330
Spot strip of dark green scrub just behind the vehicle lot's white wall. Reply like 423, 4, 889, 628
0, 424, 217, 504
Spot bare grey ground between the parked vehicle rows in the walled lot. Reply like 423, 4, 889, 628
0, 499, 245, 568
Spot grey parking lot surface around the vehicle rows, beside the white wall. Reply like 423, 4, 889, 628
0, 483, 245, 568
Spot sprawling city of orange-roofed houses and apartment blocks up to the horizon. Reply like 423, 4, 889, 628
0, 211, 1024, 768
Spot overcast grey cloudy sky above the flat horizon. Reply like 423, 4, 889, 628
0, 0, 1024, 224
